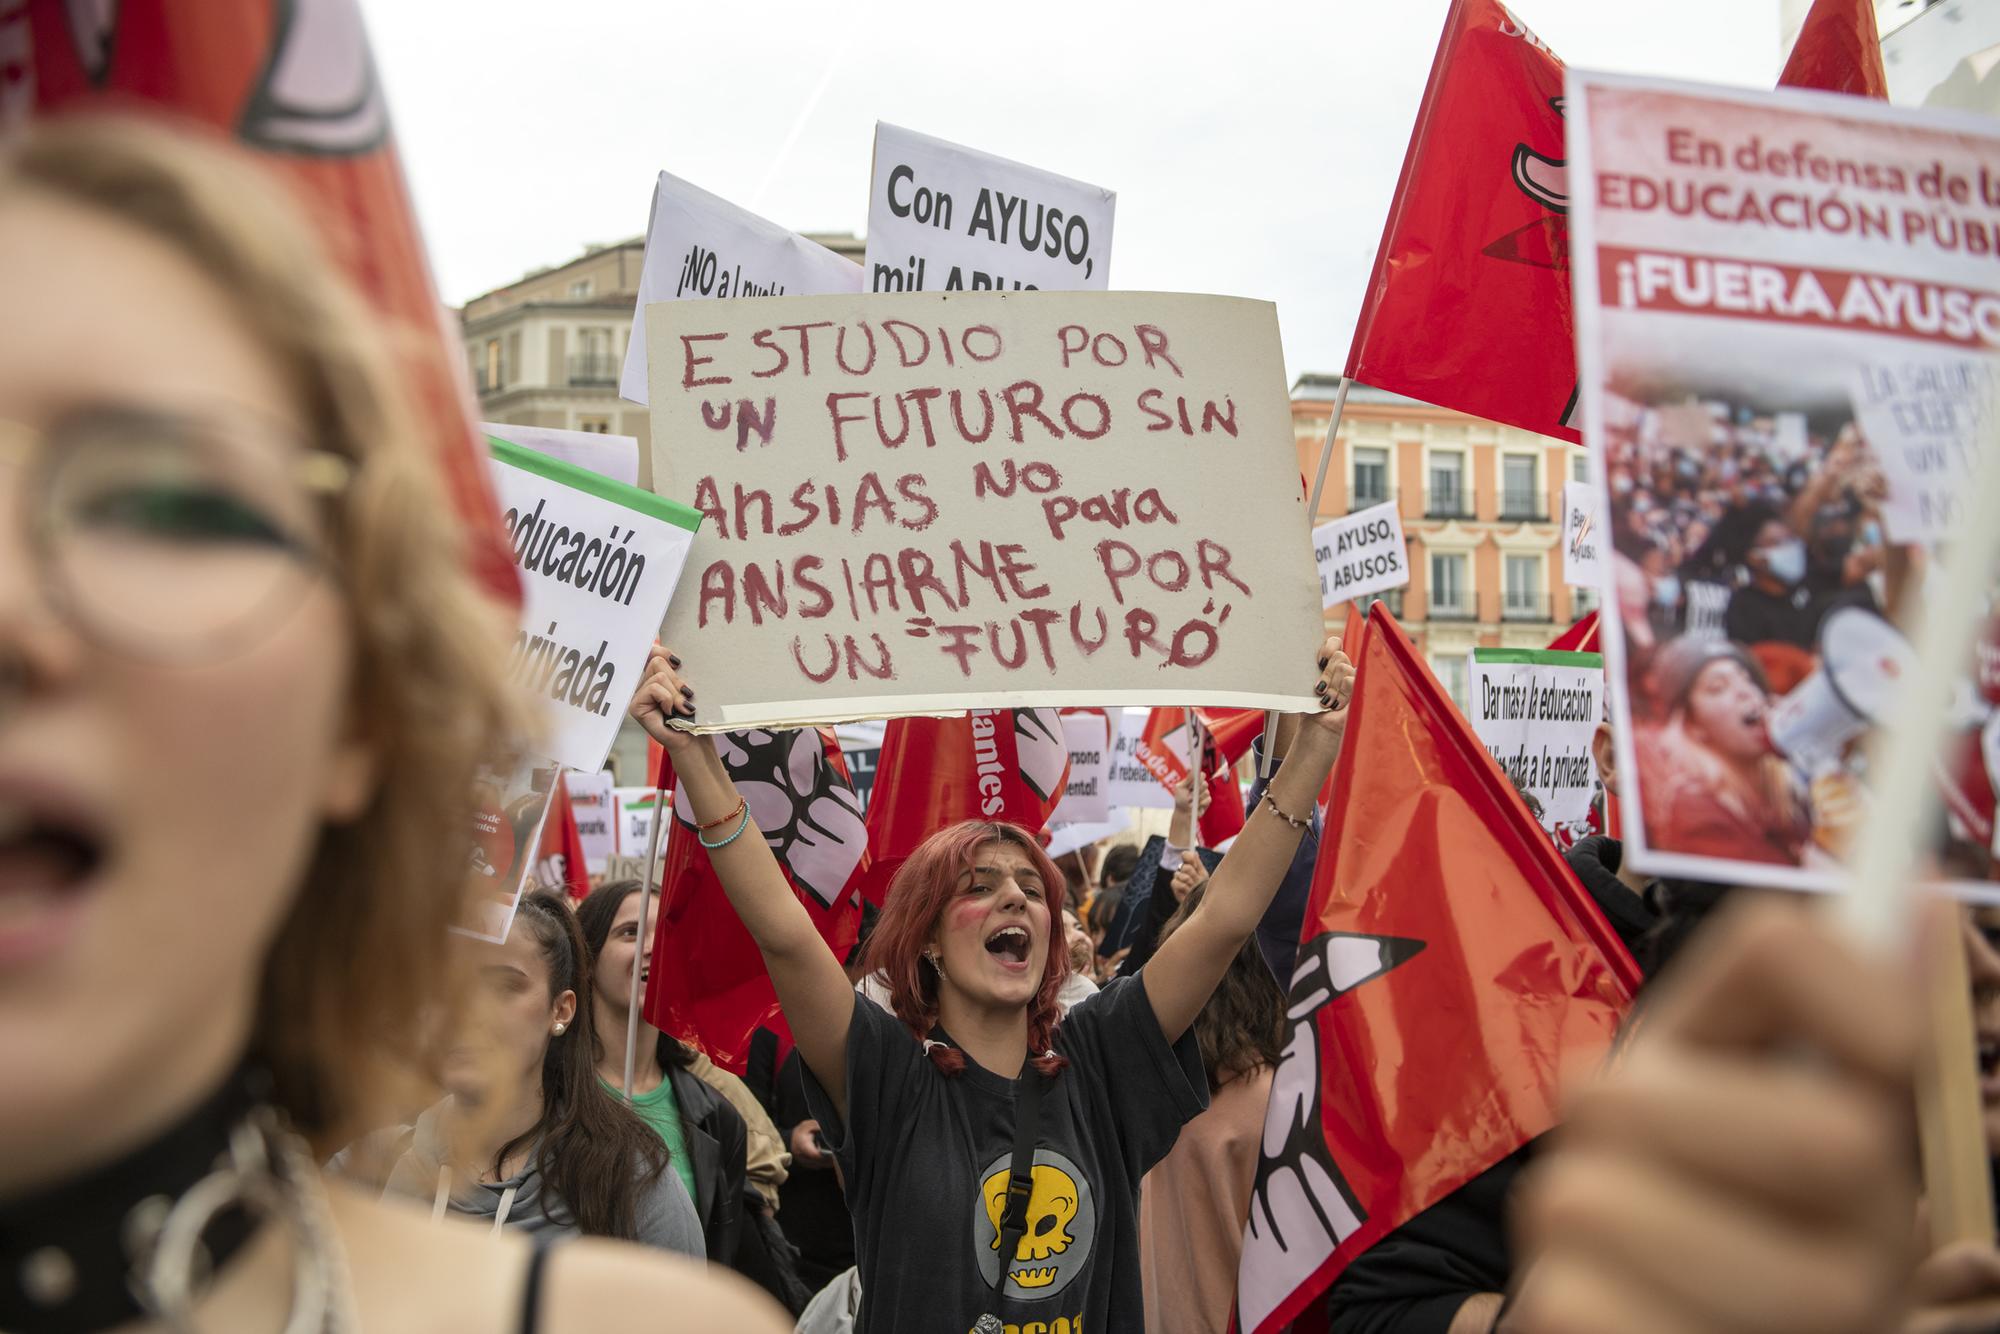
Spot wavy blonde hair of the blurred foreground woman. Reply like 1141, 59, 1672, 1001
0, 116, 528, 1144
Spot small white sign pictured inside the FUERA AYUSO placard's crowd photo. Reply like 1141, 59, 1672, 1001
1850, 348, 2000, 546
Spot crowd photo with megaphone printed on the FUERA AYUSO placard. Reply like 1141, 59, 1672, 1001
1604, 370, 2000, 880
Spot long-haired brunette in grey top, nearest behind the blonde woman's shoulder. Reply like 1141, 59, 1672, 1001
388, 892, 704, 1256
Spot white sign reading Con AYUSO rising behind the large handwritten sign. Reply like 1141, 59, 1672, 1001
862, 124, 1118, 292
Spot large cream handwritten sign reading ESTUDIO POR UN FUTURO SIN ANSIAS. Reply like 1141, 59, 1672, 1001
646, 292, 1320, 728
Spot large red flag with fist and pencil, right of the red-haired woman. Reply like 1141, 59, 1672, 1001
1238, 606, 1638, 1332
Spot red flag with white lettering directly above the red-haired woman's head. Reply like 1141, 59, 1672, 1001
862, 708, 1070, 904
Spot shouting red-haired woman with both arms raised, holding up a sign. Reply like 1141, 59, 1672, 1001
632, 640, 1354, 1334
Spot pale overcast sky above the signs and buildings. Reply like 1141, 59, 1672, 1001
362, 0, 1782, 376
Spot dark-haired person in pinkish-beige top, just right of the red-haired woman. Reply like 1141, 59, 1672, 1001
1138, 888, 1284, 1334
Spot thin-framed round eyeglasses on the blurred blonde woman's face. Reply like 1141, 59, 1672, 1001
0, 404, 352, 662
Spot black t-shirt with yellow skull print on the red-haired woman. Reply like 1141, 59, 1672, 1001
804, 978, 1208, 1334
